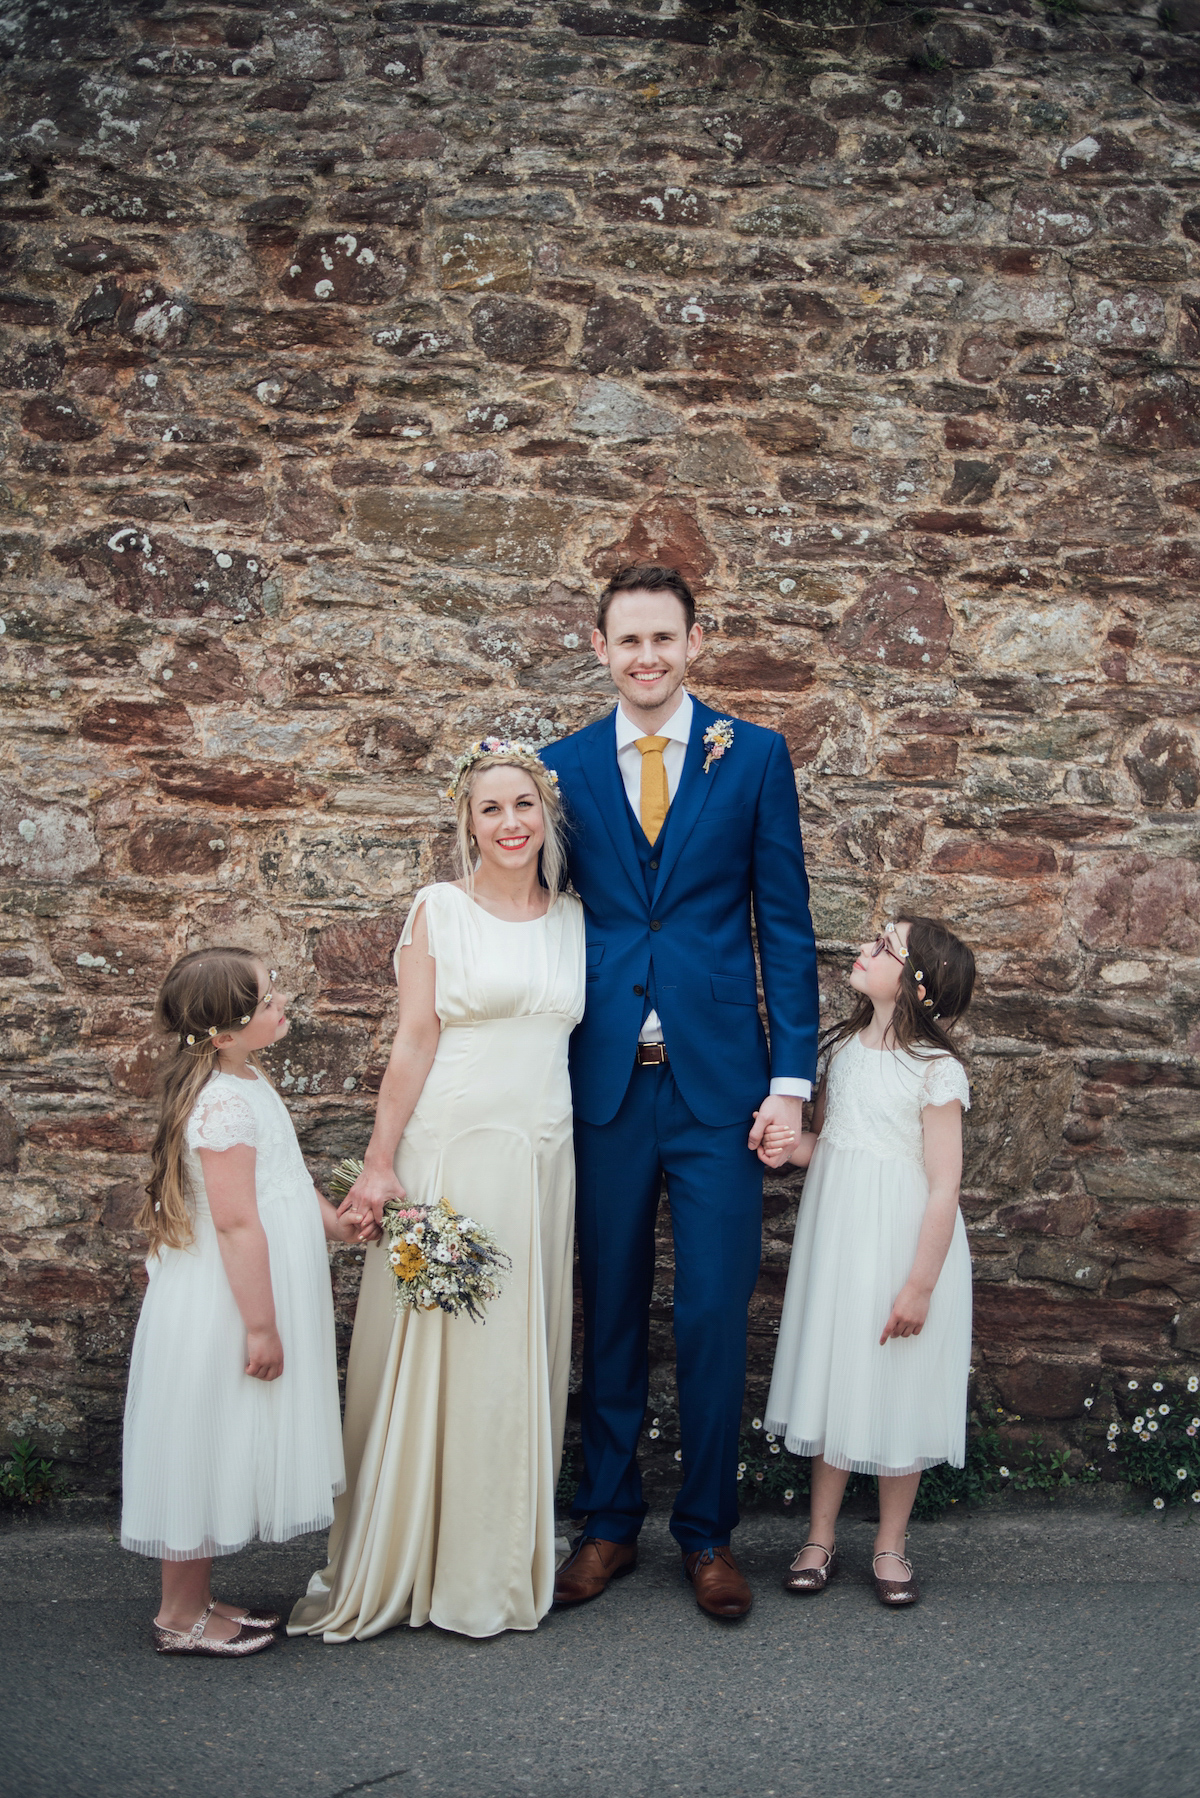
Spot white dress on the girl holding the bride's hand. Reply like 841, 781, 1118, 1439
121, 1073, 345, 1561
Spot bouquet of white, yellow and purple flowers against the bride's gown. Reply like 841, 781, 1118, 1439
329, 1156, 513, 1322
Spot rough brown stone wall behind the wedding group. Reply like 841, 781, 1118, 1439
0, 0, 1200, 1489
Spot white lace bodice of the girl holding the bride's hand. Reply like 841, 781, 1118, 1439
184, 1072, 313, 1217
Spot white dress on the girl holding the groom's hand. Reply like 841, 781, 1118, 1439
765, 1037, 972, 1474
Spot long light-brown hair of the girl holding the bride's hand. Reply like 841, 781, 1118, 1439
137, 949, 261, 1255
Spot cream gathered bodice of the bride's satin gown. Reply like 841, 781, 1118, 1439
396, 881, 583, 1030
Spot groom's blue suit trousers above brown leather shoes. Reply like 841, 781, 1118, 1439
572, 1064, 763, 1553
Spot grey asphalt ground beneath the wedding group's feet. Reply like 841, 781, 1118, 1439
0, 1509, 1200, 1798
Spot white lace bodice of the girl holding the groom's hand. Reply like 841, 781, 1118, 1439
820, 1036, 972, 1167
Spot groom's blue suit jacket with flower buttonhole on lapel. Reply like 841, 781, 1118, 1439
542, 699, 817, 1124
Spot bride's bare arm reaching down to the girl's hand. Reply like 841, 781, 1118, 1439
340, 906, 441, 1233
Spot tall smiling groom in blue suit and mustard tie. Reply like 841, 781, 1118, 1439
543, 565, 817, 1616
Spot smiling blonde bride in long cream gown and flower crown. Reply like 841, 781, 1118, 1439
288, 737, 583, 1642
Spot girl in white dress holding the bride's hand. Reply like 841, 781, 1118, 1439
121, 949, 365, 1656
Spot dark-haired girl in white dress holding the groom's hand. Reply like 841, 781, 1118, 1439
761, 917, 975, 1606
